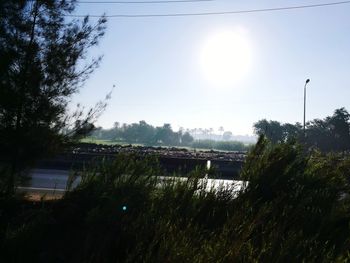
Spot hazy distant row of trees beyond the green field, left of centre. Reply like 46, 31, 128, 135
91, 121, 193, 146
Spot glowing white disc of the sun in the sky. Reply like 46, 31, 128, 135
200, 30, 252, 86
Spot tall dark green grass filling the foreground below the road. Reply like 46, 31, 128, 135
1, 139, 350, 263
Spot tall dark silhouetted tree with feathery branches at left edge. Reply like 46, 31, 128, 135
0, 0, 106, 192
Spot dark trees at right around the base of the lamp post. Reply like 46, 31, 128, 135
254, 108, 350, 152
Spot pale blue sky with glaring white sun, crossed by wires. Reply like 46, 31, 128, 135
72, 0, 350, 135
